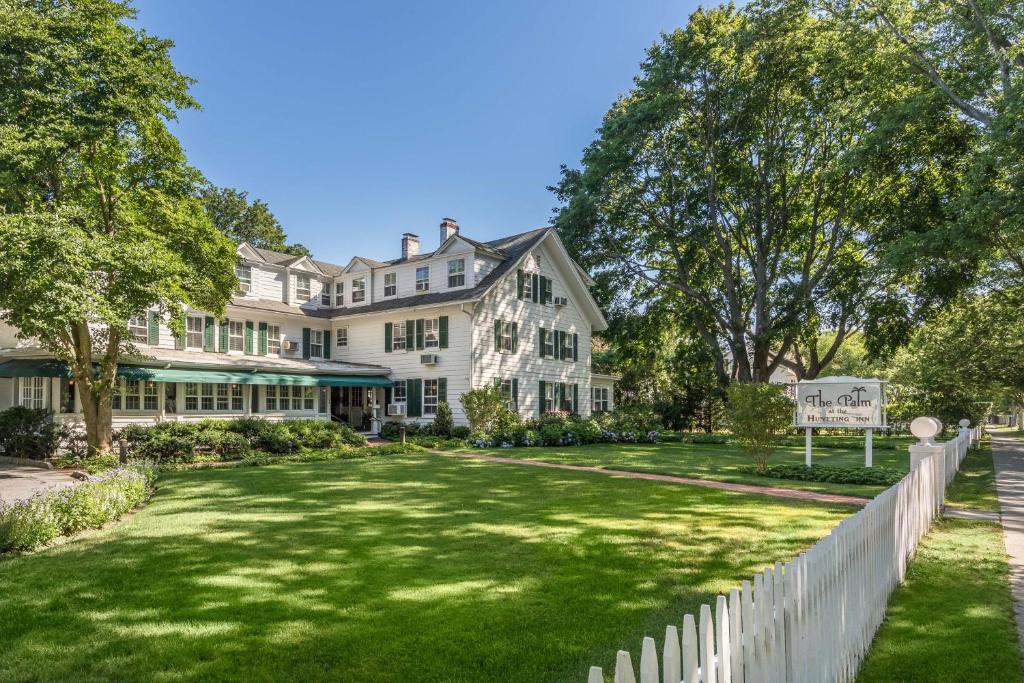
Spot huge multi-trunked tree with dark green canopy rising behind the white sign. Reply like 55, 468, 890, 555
555, 3, 968, 386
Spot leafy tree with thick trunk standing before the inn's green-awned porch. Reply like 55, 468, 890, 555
0, 0, 237, 451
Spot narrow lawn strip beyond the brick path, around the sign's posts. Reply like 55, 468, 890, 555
458, 443, 910, 498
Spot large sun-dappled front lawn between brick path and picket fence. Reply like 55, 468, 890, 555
0, 455, 850, 682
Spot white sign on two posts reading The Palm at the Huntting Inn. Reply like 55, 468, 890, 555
796, 377, 886, 467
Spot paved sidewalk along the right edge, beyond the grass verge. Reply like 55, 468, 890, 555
991, 432, 1024, 650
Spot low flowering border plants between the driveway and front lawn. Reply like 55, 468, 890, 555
0, 466, 155, 552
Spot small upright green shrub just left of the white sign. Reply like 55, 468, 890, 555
728, 382, 793, 472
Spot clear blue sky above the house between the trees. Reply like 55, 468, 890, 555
136, 0, 696, 262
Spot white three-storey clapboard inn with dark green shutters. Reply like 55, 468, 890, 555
0, 218, 615, 430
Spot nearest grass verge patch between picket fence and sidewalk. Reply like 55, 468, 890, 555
858, 519, 1022, 683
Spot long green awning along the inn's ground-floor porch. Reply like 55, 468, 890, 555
0, 358, 393, 387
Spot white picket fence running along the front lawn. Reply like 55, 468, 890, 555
587, 428, 981, 683
